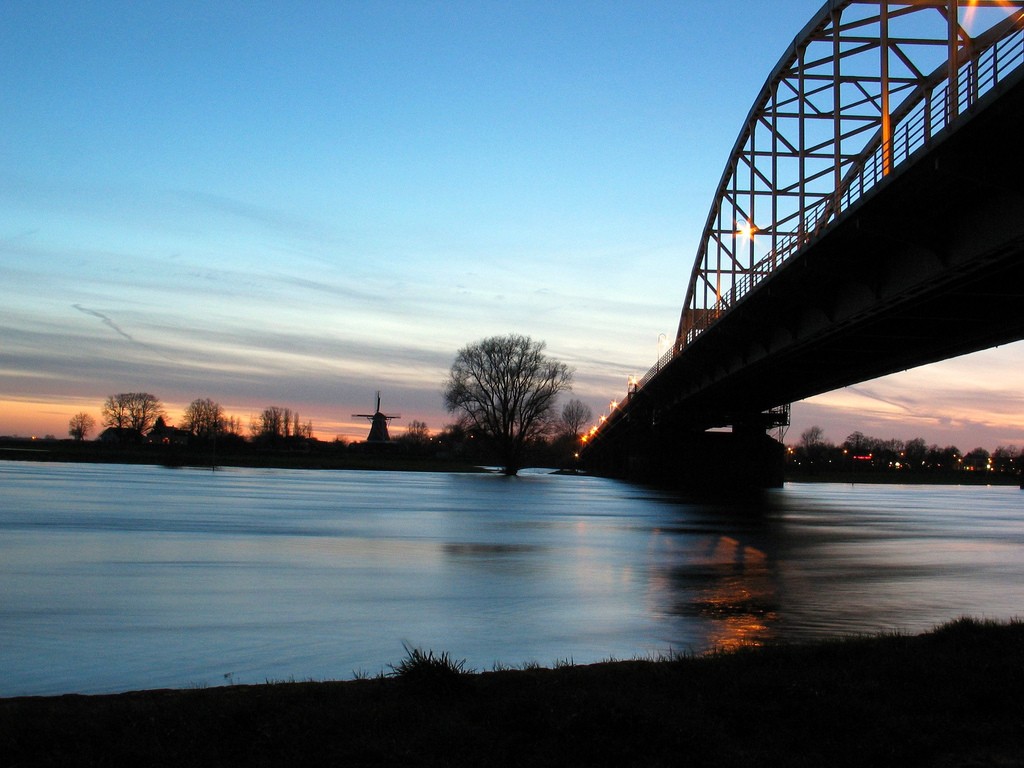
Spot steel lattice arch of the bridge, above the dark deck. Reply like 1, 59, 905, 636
587, 0, 1024, 489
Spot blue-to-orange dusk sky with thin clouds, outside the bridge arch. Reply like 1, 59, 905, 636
0, 0, 1024, 450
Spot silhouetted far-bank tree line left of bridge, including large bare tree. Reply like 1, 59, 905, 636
56, 334, 592, 468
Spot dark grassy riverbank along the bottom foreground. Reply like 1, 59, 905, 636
0, 621, 1024, 767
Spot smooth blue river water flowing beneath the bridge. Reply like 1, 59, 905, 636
0, 462, 1024, 696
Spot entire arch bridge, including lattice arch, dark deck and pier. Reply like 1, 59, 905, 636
584, 0, 1024, 493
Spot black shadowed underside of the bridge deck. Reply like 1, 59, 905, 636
636, 72, 1024, 429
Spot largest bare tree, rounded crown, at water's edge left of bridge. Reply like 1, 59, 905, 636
443, 334, 572, 475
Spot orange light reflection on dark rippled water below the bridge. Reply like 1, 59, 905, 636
650, 531, 779, 650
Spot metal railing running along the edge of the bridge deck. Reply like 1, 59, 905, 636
633, 28, 1024, 391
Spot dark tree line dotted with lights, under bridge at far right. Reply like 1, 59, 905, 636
787, 426, 1022, 475
